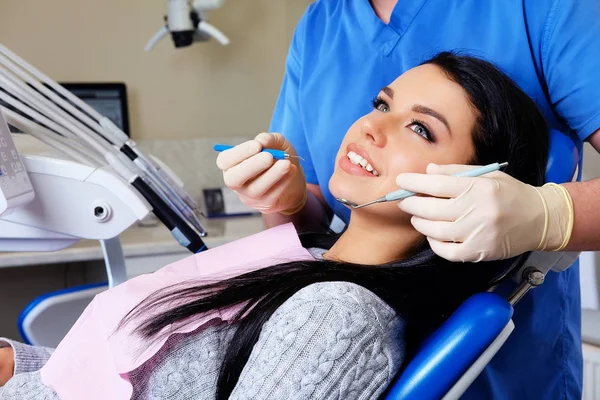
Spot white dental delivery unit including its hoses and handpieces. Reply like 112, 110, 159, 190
0, 45, 206, 253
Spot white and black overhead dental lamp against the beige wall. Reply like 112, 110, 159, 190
145, 0, 229, 51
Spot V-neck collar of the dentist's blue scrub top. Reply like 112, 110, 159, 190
350, 0, 427, 56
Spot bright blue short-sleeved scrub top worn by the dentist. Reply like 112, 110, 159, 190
270, 0, 600, 400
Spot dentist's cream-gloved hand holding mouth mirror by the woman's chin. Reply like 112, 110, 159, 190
396, 164, 573, 262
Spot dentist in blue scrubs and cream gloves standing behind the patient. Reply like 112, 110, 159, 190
219, 0, 600, 400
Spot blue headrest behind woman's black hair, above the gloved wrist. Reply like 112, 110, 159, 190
546, 129, 579, 183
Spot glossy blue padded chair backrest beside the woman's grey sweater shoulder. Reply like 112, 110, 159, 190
386, 293, 513, 400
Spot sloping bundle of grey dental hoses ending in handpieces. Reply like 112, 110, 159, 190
0, 45, 206, 252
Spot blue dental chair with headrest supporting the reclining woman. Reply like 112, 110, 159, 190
385, 130, 579, 400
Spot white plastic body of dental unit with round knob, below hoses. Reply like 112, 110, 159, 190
0, 156, 151, 251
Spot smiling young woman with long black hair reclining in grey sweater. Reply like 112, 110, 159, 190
0, 53, 548, 400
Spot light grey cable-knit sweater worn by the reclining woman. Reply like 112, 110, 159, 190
0, 282, 404, 400
